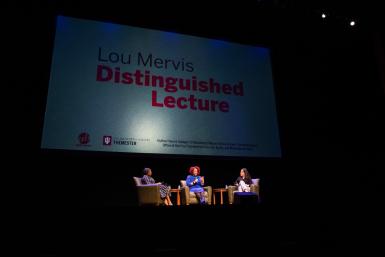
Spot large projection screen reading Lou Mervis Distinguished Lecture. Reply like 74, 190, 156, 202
42, 16, 281, 157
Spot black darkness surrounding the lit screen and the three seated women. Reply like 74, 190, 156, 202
7, 0, 385, 256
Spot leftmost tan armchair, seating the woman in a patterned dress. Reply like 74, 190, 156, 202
133, 177, 164, 206
